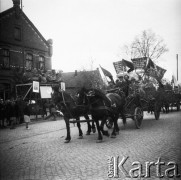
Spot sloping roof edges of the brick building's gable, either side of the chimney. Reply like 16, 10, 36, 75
0, 7, 49, 47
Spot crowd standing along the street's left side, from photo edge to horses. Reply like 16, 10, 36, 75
0, 98, 62, 129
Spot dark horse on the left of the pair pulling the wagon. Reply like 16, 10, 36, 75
52, 86, 95, 143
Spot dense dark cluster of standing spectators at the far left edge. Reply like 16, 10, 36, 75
0, 99, 30, 129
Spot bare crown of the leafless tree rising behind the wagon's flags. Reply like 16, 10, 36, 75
124, 30, 168, 61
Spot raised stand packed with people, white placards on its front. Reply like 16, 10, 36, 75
15, 68, 65, 119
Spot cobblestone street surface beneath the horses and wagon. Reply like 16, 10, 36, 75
0, 112, 181, 180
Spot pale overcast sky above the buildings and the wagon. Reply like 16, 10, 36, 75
0, 0, 181, 82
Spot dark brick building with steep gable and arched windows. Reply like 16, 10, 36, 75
0, 0, 52, 99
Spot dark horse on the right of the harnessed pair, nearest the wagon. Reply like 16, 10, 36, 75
79, 88, 126, 142
